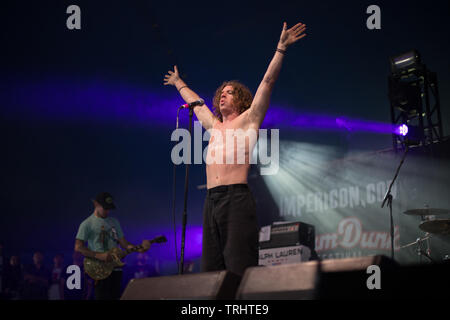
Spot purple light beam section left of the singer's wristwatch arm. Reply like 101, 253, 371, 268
0, 76, 195, 127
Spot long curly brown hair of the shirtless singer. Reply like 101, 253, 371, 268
213, 80, 253, 122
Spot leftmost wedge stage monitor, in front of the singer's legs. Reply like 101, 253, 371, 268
121, 271, 241, 300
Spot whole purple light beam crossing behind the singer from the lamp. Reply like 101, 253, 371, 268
0, 76, 406, 135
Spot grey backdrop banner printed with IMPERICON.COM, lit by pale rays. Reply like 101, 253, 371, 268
251, 143, 450, 263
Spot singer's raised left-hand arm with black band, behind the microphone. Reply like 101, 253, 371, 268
164, 66, 216, 130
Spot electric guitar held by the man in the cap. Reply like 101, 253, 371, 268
83, 236, 167, 280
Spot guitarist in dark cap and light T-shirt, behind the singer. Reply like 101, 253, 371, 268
75, 192, 151, 300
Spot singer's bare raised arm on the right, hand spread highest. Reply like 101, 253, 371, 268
248, 22, 306, 128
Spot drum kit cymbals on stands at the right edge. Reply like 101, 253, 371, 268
400, 208, 450, 262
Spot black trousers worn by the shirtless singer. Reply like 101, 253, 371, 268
202, 184, 259, 275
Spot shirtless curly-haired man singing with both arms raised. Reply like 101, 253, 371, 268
164, 22, 306, 275
